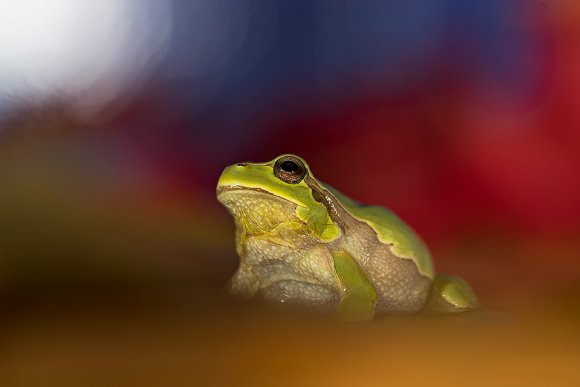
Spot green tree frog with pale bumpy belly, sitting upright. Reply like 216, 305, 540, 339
216, 154, 479, 321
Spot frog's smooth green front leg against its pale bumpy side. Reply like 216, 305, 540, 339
332, 250, 377, 321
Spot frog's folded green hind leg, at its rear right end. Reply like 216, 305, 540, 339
423, 274, 478, 314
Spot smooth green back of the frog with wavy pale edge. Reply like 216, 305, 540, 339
322, 183, 434, 278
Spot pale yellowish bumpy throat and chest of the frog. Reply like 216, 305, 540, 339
219, 190, 340, 311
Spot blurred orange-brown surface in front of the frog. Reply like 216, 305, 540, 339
0, 292, 580, 386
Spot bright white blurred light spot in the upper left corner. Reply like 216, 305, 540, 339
0, 0, 171, 116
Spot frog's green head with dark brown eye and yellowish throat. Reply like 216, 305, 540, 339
217, 154, 340, 240
